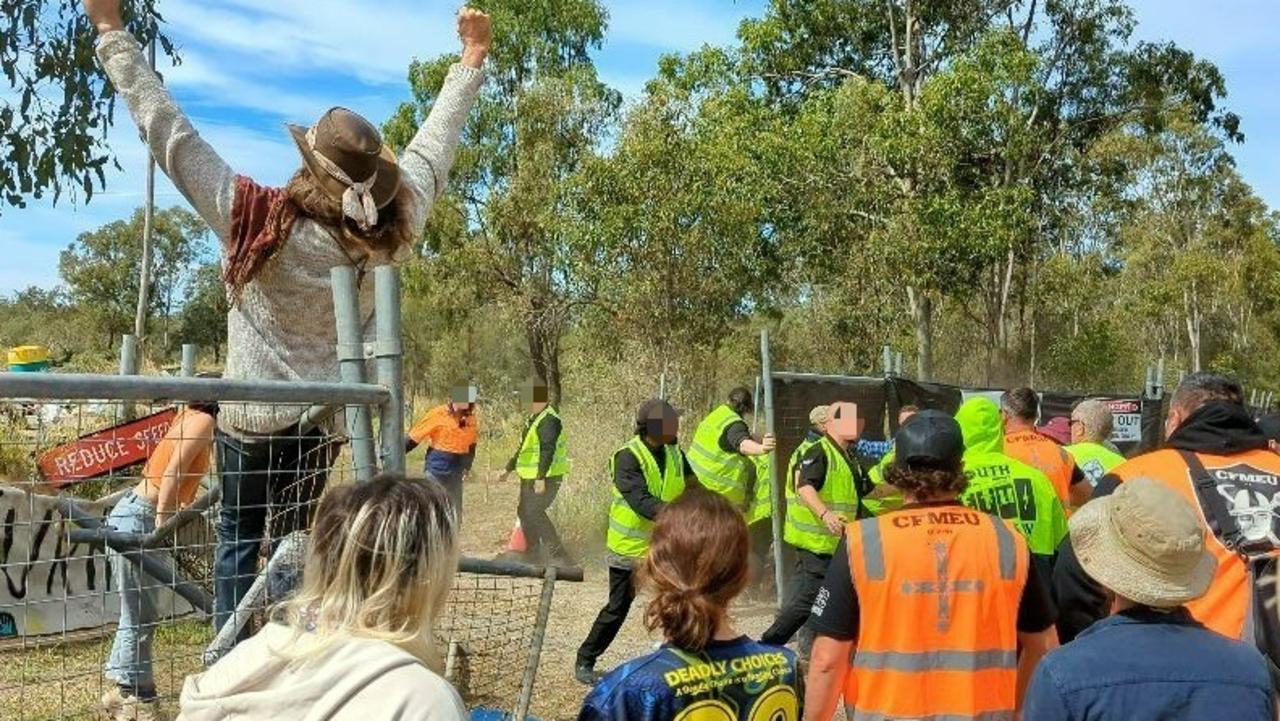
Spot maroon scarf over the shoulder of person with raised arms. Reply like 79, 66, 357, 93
223, 175, 298, 304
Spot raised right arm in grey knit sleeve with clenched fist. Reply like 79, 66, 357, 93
399, 8, 493, 223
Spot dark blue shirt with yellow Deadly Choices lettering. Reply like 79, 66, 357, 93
577, 636, 800, 721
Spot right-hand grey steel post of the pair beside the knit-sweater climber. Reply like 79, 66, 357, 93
374, 265, 404, 473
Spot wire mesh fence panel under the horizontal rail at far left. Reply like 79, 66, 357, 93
0, 398, 353, 721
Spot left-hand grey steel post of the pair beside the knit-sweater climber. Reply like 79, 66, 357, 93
329, 265, 378, 482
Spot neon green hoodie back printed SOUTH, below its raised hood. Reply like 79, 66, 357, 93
960, 451, 1066, 556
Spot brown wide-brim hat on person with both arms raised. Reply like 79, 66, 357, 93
285, 108, 401, 209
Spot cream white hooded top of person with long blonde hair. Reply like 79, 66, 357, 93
178, 624, 467, 721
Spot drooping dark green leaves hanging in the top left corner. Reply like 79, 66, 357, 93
0, 0, 175, 207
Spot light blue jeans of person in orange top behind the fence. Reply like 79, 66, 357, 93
104, 490, 161, 698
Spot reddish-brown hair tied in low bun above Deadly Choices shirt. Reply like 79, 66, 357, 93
640, 488, 749, 652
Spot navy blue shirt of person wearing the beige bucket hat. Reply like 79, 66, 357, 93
1023, 608, 1276, 721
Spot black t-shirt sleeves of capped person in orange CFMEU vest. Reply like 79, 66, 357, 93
809, 517, 1057, 640
